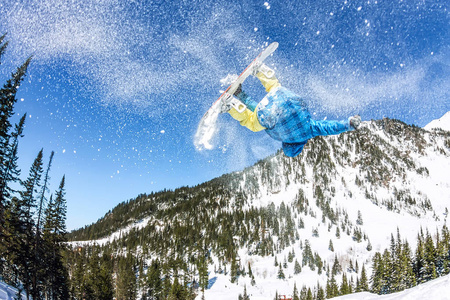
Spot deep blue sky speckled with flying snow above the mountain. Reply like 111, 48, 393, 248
0, 0, 450, 229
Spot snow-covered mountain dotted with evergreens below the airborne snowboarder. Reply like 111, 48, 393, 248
67, 119, 450, 299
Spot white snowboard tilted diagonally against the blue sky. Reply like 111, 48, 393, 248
194, 42, 278, 150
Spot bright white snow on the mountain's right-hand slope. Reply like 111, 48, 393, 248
200, 118, 450, 299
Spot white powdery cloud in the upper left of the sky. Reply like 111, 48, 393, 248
0, 0, 260, 115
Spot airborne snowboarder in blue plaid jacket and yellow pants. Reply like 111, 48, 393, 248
221, 64, 361, 157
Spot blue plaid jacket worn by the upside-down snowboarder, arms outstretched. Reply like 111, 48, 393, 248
237, 87, 351, 157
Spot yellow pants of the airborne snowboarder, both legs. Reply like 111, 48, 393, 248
228, 72, 281, 132
